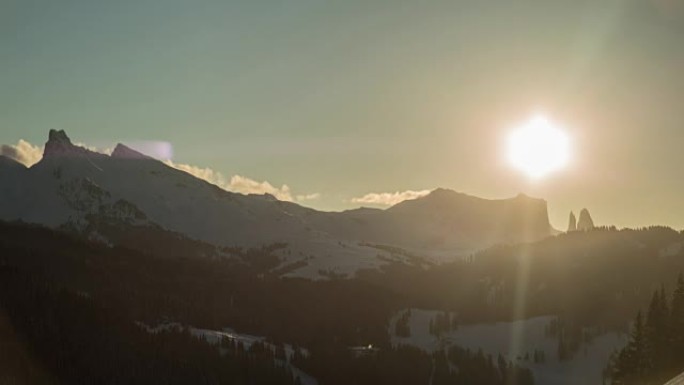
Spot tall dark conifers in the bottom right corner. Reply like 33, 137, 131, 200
610, 273, 684, 385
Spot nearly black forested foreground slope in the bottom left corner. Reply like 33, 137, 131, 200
0, 265, 295, 385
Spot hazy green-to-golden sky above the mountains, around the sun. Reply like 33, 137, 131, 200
0, 0, 684, 229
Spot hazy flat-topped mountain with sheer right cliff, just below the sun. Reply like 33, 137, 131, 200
310, 189, 553, 250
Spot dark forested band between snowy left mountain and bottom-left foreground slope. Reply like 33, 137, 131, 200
0, 219, 401, 346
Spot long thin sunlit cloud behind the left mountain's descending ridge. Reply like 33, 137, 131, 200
164, 160, 321, 202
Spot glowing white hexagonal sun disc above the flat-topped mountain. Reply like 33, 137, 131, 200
507, 116, 570, 179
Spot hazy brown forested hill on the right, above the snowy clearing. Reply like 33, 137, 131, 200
359, 227, 684, 330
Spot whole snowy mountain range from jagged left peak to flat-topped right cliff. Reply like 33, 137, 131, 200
0, 130, 553, 270
